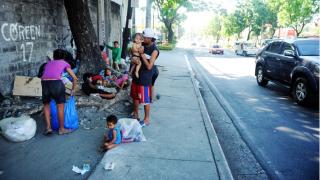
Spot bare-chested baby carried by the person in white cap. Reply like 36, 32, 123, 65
130, 33, 143, 78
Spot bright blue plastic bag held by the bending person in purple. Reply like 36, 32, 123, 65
50, 96, 79, 130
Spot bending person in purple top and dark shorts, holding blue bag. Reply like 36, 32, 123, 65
41, 49, 78, 135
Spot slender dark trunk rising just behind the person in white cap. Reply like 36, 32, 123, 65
121, 0, 132, 59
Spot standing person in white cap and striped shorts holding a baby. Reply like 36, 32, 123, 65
130, 28, 160, 126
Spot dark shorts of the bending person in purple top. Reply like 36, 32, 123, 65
41, 80, 66, 104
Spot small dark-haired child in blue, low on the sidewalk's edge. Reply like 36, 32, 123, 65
103, 115, 122, 150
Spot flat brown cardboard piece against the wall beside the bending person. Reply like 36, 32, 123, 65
12, 76, 42, 96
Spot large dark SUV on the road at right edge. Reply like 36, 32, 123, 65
255, 38, 320, 105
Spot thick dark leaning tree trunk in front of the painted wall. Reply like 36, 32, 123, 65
64, 0, 103, 75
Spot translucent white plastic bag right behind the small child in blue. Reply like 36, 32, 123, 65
118, 118, 146, 142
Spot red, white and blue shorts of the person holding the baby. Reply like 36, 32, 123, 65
130, 82, 151, 105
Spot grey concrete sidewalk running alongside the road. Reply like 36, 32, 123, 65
89, 50, 232, 180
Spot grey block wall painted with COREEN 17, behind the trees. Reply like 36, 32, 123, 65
0, 0, 122, 95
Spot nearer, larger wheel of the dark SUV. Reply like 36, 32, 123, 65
292, 77, 312, 105
